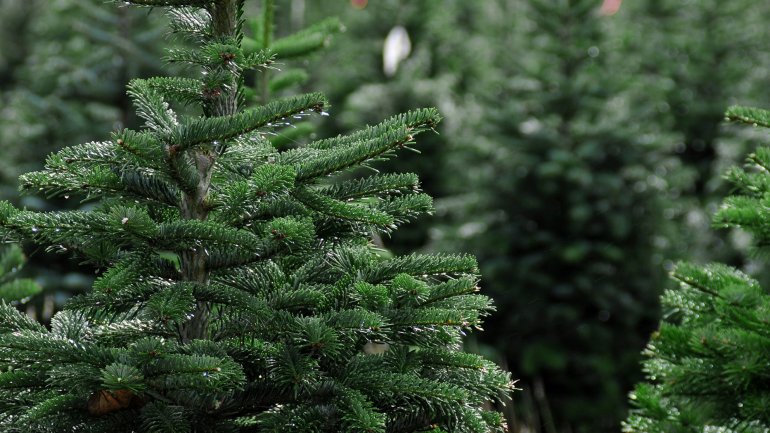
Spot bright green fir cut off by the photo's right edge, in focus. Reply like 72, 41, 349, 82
624, 107, 770, 433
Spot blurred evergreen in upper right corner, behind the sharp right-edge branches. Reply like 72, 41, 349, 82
611, 0, 770, 270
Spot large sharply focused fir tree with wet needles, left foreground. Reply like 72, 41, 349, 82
0, 0, 511, 433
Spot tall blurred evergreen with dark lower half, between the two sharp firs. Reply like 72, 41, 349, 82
435, 0, 676, 432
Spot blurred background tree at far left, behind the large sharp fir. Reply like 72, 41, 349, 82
0, 0, 164, 321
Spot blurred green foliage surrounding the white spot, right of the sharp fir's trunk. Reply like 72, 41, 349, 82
307, 0, 496, 253
